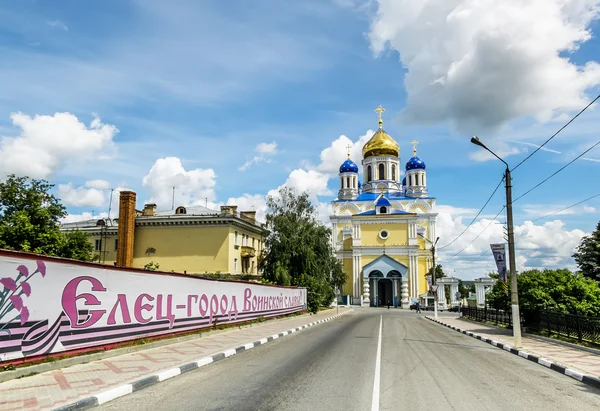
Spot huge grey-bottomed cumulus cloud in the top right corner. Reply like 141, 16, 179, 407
369, 0, 600, 129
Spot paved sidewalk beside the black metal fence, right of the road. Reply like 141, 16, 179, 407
427, 317, 600, 388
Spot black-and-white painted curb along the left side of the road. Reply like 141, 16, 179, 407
54, 310, 352, 411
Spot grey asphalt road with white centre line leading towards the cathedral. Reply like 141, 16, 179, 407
100, 308, 600, 411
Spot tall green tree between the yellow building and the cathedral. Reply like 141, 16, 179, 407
260, 187, 346, 312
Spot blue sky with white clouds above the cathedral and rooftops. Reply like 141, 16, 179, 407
0, 0, 600, 279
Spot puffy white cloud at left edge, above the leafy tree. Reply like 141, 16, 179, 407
0, 113, 118, 178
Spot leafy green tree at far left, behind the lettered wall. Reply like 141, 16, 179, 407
0, 174, 93, 261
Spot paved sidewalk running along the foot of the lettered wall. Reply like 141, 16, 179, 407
0, 307, 352, 411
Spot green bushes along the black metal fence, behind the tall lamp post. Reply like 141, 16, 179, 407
487, 269, 600, 318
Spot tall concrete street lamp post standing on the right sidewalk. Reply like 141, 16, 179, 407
471, 136, 521, 348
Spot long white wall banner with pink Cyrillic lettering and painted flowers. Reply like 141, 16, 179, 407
0, 250, 306, 362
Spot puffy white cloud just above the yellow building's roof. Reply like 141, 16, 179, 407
142, 157, 216, 210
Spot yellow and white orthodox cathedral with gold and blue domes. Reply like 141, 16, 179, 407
330, 106, 437, 308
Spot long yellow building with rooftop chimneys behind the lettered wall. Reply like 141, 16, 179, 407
61, 197, 267, 275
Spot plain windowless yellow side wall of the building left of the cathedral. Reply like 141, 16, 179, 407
133, 226, 232, 273
